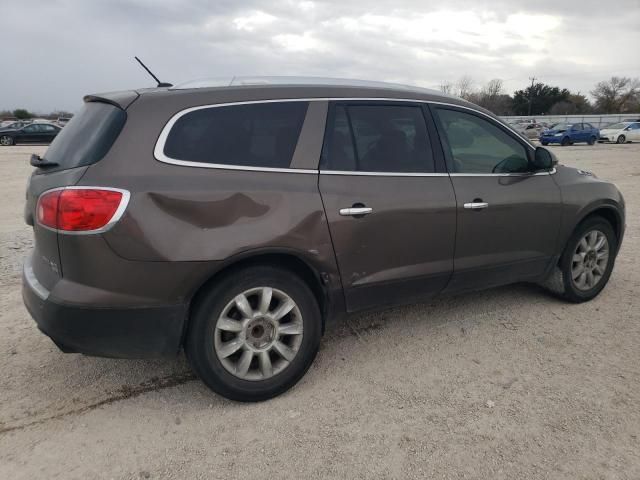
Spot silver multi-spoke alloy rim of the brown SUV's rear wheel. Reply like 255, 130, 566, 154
214, 287, 303, 381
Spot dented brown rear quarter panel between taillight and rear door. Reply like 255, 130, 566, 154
81, 95, 339, 304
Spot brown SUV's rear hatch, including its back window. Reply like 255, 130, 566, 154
24, 92, 132, 290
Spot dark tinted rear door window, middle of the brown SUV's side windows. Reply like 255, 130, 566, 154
326, 105, 434, 172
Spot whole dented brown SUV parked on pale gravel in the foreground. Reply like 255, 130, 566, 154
23, 80, 625, 401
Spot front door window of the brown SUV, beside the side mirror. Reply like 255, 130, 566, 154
436, 108, 529, 173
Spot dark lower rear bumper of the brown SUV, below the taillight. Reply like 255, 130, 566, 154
22, 258, 187, 358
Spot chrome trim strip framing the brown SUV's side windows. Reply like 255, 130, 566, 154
153, 97, 544, 177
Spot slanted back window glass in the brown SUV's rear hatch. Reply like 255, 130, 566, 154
44, 102, 127, 173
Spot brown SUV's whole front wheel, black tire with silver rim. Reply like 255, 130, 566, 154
558, 216, 618, 303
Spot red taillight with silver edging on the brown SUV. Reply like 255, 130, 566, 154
36, 187, 129, 233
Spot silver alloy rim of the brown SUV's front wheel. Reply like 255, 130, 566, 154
571, 230, 609, 291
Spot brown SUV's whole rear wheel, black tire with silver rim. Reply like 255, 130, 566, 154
185, 266, 322, 402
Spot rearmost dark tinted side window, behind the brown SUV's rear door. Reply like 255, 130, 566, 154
164, 102, 308, 168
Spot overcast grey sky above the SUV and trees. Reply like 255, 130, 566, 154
5, 0, 640, 112
